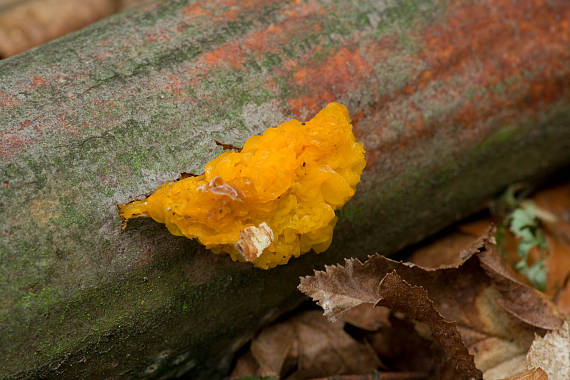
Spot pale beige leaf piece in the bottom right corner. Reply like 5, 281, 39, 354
527, 321, 570, 380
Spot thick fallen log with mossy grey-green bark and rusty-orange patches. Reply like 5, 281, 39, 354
0, 0, 570, 378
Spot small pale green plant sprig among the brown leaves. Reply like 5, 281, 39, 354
491, 184, 553, 291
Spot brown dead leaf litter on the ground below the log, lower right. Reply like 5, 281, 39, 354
232, 184, 570, 380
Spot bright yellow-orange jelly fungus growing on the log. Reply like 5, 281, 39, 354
119, 103, 366, 269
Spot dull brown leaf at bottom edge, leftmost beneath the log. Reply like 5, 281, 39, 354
231, 310, 382, 380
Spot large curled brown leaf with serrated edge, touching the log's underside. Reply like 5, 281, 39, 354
299, 230, 562, 378
